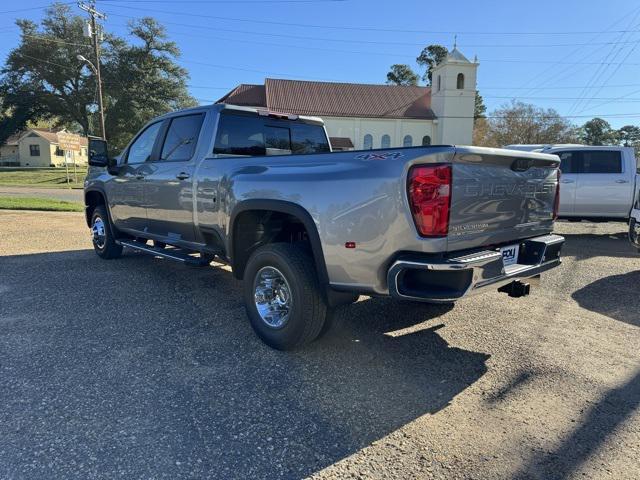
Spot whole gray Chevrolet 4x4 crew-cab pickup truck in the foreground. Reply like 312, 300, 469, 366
85, 105, 564, 350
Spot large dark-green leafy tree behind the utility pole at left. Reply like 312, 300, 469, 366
0, 4, 195, 149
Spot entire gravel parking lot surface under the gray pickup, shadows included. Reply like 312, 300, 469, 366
0, 211, 640, 480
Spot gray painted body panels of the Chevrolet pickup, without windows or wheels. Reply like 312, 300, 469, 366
85, 105, 560, 294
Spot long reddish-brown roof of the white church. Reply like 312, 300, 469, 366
216, 78, 436, 120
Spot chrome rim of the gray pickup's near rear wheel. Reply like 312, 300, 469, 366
253, 267, 293, 328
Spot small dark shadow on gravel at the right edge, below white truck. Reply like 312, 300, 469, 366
571, 270, 640, 327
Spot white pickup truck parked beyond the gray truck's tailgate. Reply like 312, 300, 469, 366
504, 145, 640, 221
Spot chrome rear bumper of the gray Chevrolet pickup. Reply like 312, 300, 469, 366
387, 235, 564, 303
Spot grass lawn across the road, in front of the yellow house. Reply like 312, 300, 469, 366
0, 166, 87, 188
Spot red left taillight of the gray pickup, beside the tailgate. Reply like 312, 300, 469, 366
407, 165, 451, 237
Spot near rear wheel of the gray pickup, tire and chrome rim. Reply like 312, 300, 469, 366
244, 243, 327, 350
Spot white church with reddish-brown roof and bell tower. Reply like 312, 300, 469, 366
218, 48, 479, 150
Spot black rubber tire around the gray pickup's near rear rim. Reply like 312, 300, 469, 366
243, 243, 327, 350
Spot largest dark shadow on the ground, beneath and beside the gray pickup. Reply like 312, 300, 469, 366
0, 250, 489, 479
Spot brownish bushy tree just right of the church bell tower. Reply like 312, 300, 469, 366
474, 101, 576, 147
